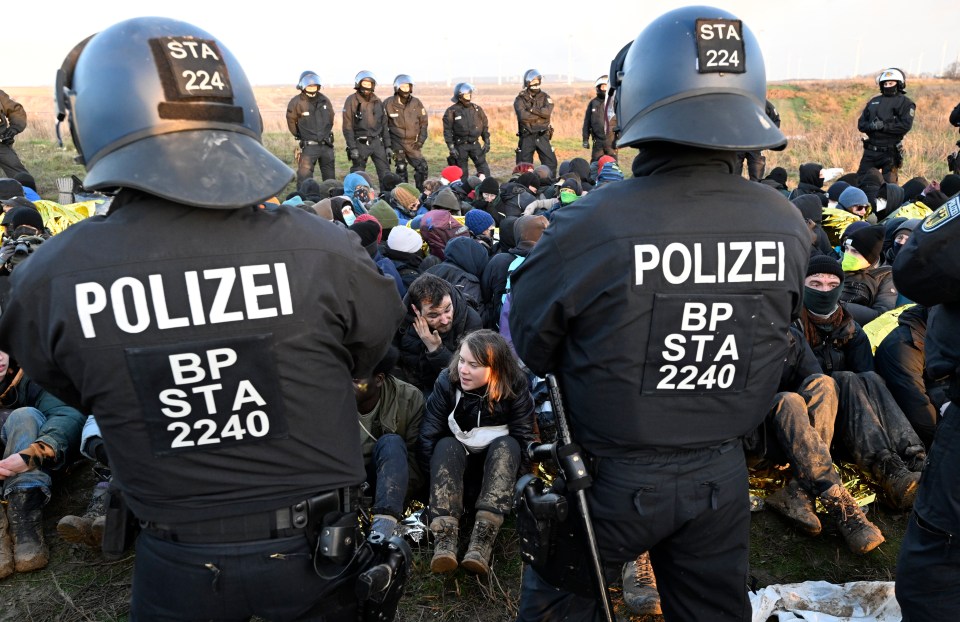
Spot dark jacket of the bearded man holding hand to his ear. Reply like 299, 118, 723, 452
394, 286, 481, 393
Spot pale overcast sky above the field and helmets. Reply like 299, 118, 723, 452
0, 0, 960, 88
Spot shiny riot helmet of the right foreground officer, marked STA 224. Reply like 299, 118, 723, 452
611, 6, 787, 151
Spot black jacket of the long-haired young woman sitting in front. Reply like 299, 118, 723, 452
417, 369, 536, 473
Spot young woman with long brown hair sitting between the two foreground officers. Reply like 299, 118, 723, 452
418, 330, 535, 574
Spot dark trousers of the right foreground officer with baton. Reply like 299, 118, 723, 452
517, 439, 752, 622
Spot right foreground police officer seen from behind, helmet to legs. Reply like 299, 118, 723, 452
510, 7, 810, 621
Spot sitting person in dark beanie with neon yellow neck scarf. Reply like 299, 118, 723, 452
840, 225, 897, 326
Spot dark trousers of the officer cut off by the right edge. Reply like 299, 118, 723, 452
896, 403, 960, 622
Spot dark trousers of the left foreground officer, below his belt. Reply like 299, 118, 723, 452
130, 531, 357, 622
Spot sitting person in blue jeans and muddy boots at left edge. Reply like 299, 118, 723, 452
0, 352, 86, 579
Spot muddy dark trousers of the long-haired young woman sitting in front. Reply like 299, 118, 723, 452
430, 436, 520, 519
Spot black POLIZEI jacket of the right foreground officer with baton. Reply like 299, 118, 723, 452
510, 147, 810, 457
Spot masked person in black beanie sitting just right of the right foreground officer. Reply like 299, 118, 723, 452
799, 255, 926, 510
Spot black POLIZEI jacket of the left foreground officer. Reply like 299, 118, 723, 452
0, 190, 403, 523
